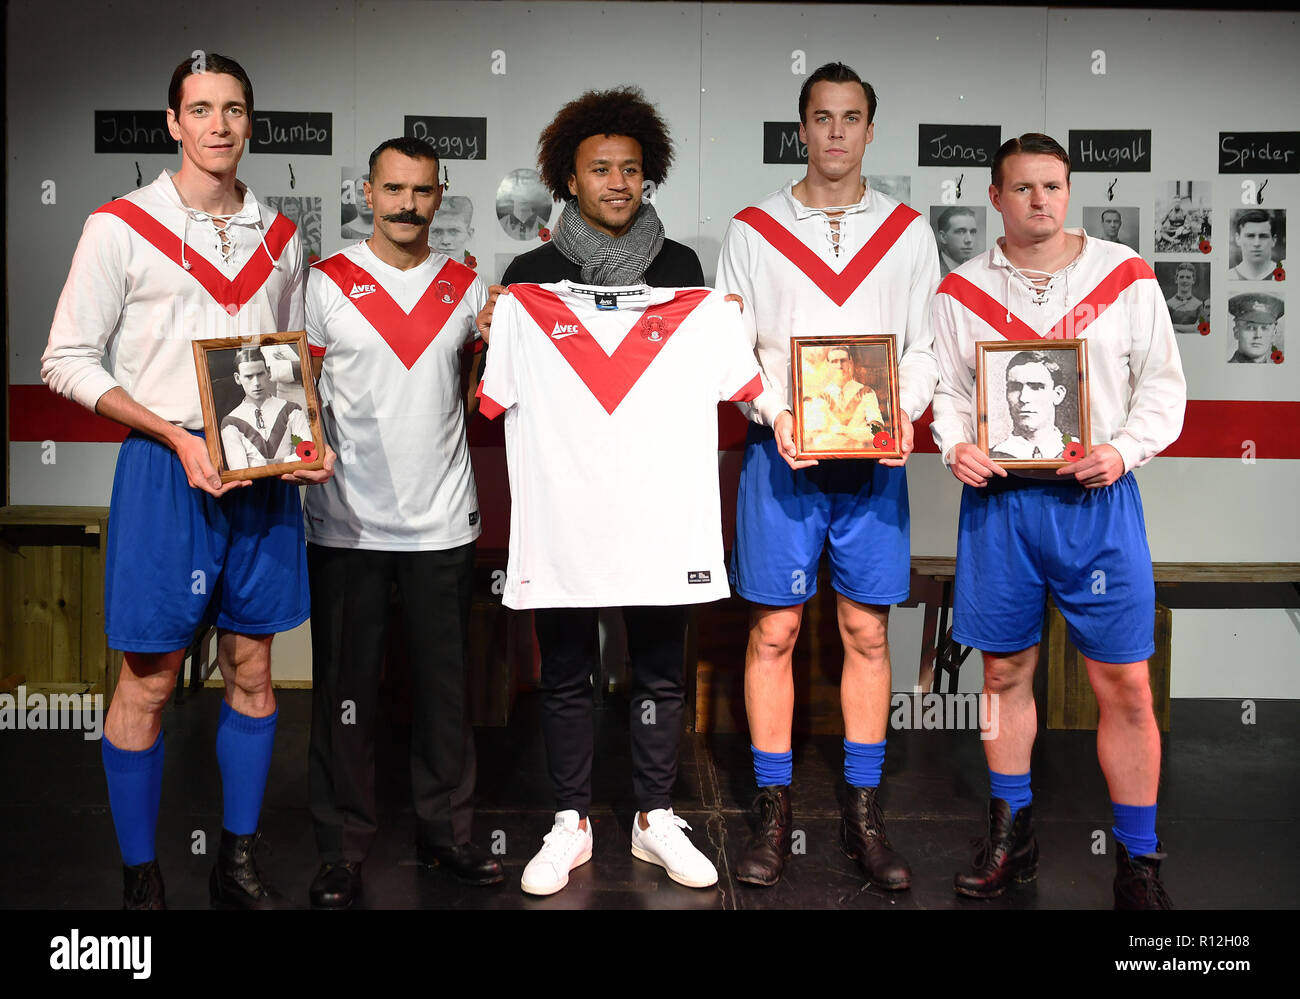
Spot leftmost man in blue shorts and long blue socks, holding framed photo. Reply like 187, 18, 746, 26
42, 52, 334, 909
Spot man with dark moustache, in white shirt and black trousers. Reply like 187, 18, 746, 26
307, 138, 502, 908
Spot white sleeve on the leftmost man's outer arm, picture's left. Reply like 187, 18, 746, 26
40, 215, 130, 411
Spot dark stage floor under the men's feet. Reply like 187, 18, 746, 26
0, 689, 1300, 911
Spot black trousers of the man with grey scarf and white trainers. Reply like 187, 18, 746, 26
533, 606, 686, 816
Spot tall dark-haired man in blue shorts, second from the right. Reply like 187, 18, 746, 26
718, 62, 939, 890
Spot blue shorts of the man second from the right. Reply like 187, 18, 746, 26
731, 423, 911, 607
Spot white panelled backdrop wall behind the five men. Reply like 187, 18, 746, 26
5, 0, 1300, 697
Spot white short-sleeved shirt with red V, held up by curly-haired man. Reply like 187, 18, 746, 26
480, 281, 762, 609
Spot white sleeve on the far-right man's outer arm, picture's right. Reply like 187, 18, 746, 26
1109, 281, 1187, 472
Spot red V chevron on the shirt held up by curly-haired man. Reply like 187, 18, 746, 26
510, 285, 709, 415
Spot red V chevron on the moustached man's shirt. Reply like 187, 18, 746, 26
312, 254, 475, 371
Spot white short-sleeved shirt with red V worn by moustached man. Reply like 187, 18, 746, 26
304, 242, 488, 552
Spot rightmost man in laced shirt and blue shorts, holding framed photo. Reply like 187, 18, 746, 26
933, 133, 1187, 908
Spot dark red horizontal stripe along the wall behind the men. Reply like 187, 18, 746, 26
9, 385, 1300, 460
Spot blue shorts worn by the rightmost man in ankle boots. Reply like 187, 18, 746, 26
953, 472, 1156, 663
